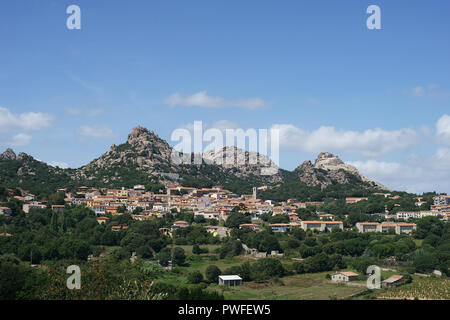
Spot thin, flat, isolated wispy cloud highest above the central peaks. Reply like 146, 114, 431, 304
164, 91, 269, 109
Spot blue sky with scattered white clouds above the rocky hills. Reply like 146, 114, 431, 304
0, 0, 450, 192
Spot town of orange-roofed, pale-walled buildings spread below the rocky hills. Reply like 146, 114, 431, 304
0, 185, 450, 238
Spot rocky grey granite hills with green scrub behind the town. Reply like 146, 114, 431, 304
0, 127, 386, 194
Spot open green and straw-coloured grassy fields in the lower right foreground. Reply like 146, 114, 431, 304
160, 245, 450, 300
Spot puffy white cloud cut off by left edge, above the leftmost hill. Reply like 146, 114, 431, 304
0, 107, 54, 133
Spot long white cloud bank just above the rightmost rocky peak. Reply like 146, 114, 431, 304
271, 124, 419, 157
